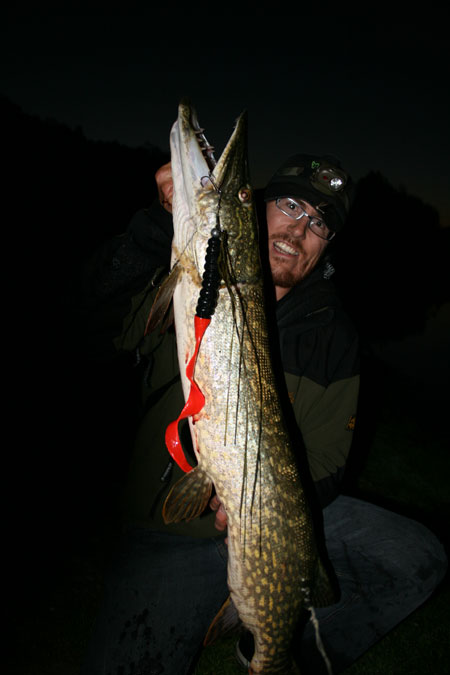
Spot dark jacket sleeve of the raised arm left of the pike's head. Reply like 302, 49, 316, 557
75, 201, 173, 360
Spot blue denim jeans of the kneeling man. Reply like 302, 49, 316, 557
82, 495, 447, 675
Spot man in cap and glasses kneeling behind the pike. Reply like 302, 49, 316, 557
83, 155, 446, 675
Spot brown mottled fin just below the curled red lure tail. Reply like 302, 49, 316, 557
162, 466, 212, 524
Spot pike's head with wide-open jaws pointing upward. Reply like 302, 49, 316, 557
170, 100, 260, 283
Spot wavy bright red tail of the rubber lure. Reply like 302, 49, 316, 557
166, 316, 211, 473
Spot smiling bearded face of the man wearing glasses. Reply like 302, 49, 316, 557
266, 197, 328, 300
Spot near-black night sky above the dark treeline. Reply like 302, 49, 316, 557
0, 2, 450, 226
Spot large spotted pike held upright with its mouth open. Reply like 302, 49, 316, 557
151, 101, 333, 675
